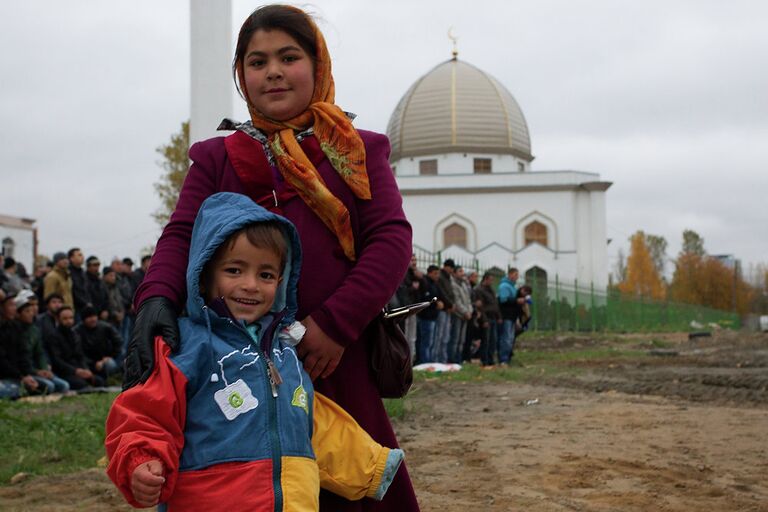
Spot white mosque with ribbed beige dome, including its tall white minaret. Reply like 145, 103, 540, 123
190, 0, 611, 290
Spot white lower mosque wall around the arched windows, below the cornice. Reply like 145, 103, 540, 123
403, 184, 608, 289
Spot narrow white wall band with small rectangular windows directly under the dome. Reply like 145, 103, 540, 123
392, 153, 530, 176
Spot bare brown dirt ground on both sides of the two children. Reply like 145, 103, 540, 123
0, 332, 768, 512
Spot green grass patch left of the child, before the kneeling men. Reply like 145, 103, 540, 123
0, 393, 116, 485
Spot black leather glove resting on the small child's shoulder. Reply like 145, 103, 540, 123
123, 297, 179, 391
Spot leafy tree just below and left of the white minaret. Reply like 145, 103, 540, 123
152, 121, 189, 227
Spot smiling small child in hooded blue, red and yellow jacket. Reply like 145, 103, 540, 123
105, 193, 403, 511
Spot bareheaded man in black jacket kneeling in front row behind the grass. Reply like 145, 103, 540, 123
48, 305, 104, 390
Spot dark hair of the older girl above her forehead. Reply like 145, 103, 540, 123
232, 5, 317, 88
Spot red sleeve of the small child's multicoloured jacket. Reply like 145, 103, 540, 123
104, 336, 187, 507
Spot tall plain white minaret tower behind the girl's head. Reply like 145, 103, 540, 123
189, 0, 234, 144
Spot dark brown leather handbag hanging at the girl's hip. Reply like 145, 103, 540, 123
363, 300, 434, 398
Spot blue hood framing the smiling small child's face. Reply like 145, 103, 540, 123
187, 192, 301, 323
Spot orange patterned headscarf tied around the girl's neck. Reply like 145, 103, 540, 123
237, 6, 371, 261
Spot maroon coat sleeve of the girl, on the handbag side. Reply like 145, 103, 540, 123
310, 132, 412, 345
